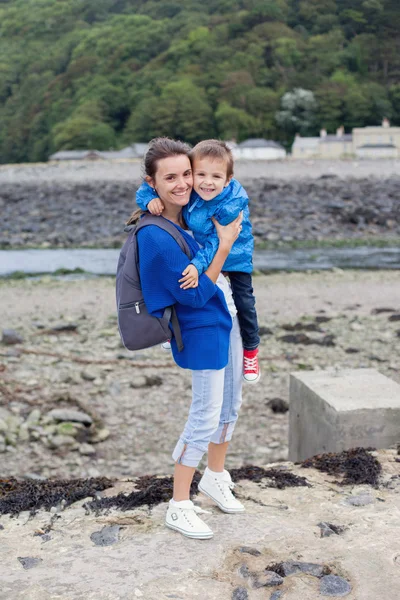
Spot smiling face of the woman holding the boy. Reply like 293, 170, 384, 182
146, 154, 193, 207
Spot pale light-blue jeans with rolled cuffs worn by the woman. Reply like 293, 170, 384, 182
172, 316, 243, 467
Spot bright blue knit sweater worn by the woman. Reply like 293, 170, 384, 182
137, 220, 232, 370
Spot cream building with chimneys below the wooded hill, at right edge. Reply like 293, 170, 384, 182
292, 119, 400, 159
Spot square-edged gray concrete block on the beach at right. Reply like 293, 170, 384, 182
289, 369, 400, 462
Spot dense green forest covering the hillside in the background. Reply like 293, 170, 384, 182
0, 0, 400, 163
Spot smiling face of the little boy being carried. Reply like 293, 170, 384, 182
193, 158, 232, 202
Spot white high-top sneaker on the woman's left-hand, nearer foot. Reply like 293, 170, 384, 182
165, 500, 214, 540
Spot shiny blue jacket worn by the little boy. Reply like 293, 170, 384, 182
136, 179, 254, 275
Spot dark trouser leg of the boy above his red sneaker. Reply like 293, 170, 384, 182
228, 271, 260, 350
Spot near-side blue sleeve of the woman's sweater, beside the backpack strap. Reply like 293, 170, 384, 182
137, 225, 218, 313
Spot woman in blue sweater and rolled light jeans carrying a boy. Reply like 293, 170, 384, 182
133, 138, 244, 539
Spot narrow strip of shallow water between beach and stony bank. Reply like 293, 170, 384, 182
0, 246, 400, 277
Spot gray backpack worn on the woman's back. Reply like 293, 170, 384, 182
116, 213, 192, 352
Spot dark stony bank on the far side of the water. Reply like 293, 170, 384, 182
0, 161, 400, 249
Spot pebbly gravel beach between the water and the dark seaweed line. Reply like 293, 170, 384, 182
0, 271, 400, 477
